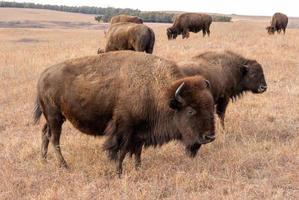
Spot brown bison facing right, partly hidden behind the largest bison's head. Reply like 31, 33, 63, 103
178, 51, 267, 127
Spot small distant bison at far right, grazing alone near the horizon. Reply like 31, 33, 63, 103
266, 13, 288, 34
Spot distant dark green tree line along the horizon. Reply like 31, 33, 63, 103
0, 1, 231, 23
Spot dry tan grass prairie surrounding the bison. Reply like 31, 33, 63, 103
0, 10, 299, 200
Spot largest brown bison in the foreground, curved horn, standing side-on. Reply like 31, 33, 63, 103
34, 51, 215, 176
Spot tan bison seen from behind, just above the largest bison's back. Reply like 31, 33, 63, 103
98, 22, 155, 54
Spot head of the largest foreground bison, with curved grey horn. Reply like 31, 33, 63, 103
169, 76, 215, 156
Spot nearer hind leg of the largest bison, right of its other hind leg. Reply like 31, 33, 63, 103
48, 115, 67, 168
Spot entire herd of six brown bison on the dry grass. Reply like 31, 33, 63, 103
34, 13, 288, 175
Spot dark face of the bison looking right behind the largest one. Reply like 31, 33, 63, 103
242, 61, 267, 93
